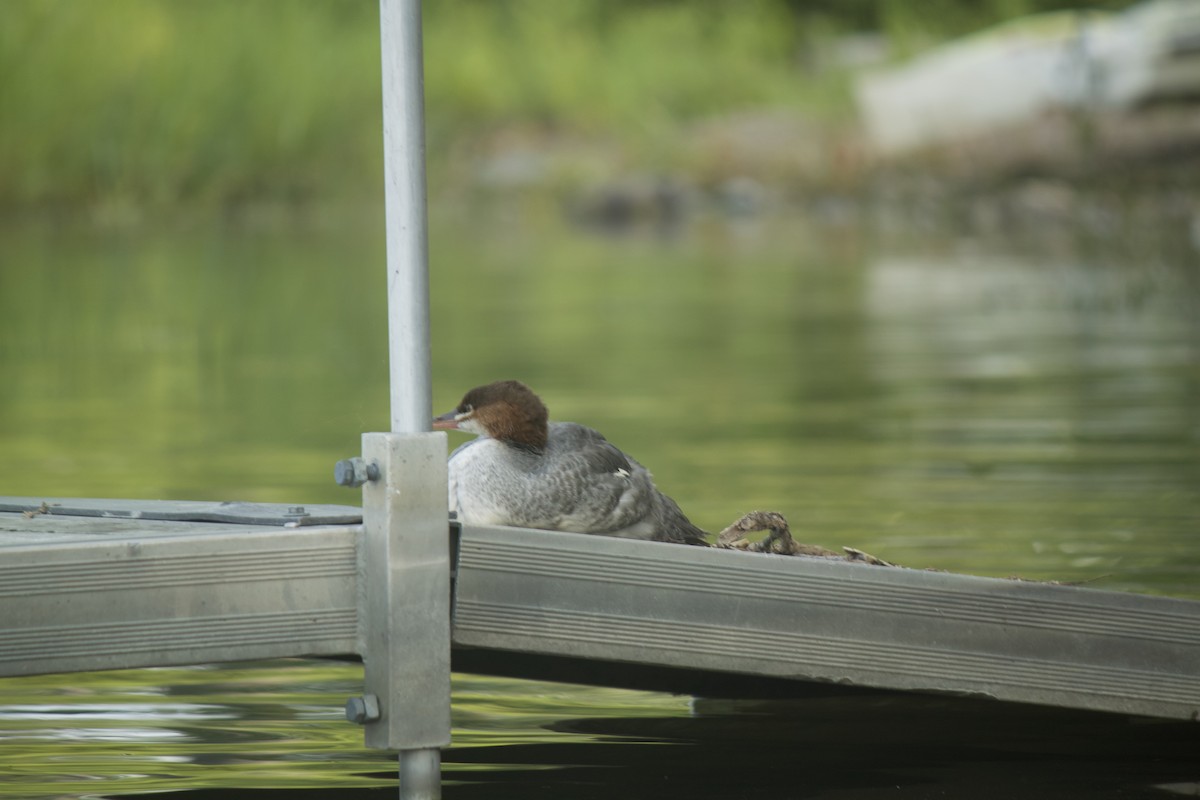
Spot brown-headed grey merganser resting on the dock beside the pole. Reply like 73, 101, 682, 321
433, 380, 708, 546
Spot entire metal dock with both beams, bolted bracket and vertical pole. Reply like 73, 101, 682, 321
9, 0, 1200, 800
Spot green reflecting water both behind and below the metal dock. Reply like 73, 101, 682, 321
0, 207, 1200, 800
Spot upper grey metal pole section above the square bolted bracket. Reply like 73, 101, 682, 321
379, 0, 433, 433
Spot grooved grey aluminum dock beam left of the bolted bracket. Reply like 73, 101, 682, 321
0, 515, 362, 675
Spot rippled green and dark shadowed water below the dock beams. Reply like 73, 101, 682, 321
0, 661, 1200, 800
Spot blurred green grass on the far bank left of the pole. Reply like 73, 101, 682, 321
0, 0, 379, 207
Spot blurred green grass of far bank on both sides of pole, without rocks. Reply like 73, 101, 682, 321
0, 0, 1137, 215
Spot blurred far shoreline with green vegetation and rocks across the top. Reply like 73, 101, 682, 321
0, 0, 1200, 244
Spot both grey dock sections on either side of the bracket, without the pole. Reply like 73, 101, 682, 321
0, 498, 1200, 721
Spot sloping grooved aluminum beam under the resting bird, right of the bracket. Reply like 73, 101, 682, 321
452, 527, 1200, 720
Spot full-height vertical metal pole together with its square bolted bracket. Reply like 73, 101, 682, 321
362, 0, 450, 800
